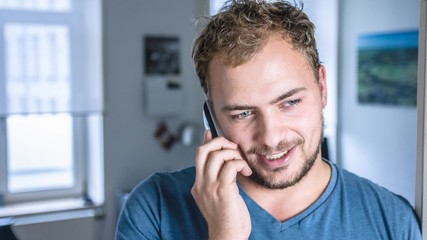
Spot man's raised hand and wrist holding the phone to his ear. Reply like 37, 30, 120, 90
191, 131, 252, 239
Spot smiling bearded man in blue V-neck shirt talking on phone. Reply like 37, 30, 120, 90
117, 0, 421, 239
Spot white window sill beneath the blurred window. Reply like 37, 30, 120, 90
0, 198, 103, 225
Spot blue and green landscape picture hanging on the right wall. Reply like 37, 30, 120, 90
357, 31, 418, 107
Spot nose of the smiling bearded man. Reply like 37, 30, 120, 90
257, 114, 284, 148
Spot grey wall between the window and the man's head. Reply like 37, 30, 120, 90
99, 0, 207, 240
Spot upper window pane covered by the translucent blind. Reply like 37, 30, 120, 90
4, 23, 71, 113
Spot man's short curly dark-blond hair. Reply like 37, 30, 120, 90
192, 0, 320, 94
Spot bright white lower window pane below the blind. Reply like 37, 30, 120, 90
6, 114, 75, 193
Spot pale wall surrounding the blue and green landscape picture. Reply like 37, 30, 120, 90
338, 0, 419, 204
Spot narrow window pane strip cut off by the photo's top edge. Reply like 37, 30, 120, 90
0, 0, 71, 11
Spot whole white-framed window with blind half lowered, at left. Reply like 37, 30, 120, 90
0, 0, 102, 204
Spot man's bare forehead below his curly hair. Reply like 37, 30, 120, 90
208, 38, 315, 104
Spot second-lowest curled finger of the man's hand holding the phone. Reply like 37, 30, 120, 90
204, 149, 246, 181
